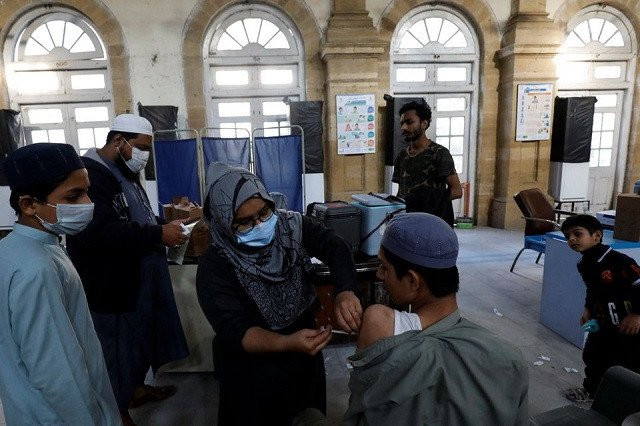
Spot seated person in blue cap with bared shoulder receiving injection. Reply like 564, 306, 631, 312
344, 213, 529, 425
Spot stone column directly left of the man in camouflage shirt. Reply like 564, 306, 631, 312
321, 0, 385, 201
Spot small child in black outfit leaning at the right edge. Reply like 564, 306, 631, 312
561, 214, 640, 402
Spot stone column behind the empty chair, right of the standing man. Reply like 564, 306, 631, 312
489, 0, 562, 229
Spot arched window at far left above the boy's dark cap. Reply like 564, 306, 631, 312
4, 7, 113, 154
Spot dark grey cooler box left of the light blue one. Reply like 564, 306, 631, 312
313, 201, 362, 253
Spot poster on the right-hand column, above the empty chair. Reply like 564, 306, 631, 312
516, 83, 553, 141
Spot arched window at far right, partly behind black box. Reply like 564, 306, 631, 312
557, 6, 637, 210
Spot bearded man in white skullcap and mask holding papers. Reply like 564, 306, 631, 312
67, 114, 188, 425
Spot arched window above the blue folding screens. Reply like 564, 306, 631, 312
203, 4, 304, 137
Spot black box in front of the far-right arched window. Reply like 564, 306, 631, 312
551, 96, 596, 163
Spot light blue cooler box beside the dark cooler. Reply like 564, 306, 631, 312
351, 194, 405, 256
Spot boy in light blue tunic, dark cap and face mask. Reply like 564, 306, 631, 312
0, 143, 120, 425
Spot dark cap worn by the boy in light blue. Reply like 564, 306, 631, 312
2, 143, 84, 191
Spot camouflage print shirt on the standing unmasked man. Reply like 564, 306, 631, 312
391, 141, 456, 198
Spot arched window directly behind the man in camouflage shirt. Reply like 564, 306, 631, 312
390, 6, 479, 218
